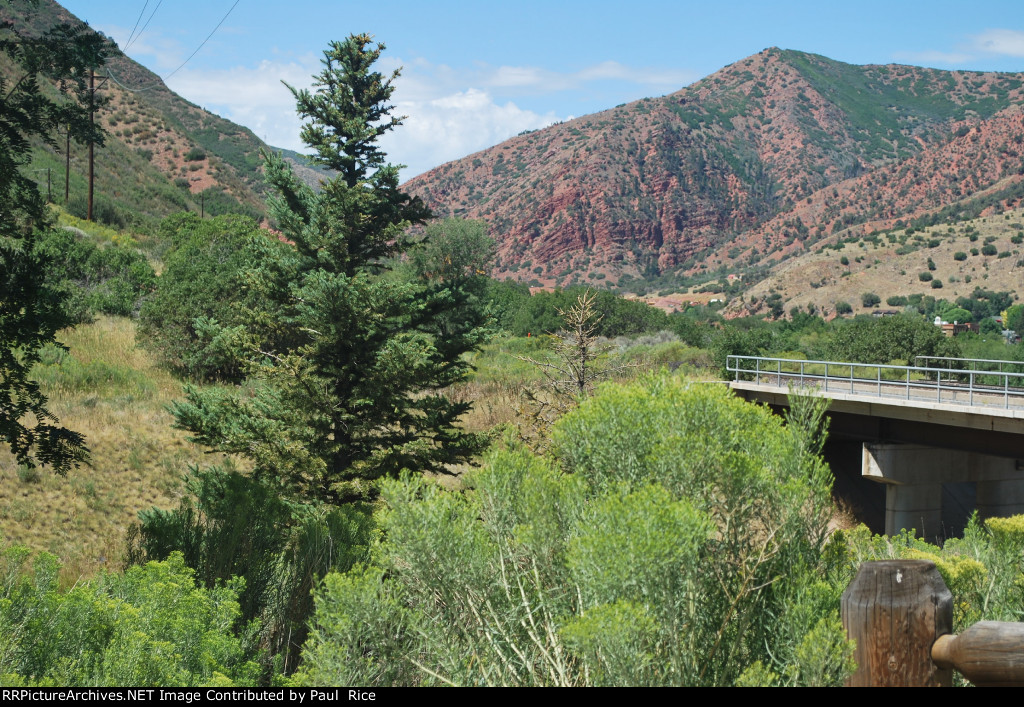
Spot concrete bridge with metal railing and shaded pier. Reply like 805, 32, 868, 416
727, 356, 1024, 540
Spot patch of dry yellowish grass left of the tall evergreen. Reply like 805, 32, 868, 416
0, 318, 220, 581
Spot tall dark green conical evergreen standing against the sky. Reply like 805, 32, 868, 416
175, 35, 482, 503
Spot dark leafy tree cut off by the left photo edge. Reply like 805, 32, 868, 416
0, 0, 110, 473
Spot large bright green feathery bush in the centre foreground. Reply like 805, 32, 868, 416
297, 377, 850, 684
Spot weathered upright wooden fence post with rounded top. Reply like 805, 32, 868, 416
842, 559, 953, 688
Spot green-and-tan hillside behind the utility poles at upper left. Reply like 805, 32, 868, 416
0, 0, 299, 225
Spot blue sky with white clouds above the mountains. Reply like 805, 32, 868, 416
61, 0, 1024, 178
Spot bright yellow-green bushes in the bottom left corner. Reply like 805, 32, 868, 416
0, 547, 258, 688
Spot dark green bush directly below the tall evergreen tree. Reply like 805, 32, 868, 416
128, 466, 371, 671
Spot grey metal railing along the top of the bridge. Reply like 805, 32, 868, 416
726, 356, 1024, 410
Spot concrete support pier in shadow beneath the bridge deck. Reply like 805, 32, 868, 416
861, 443, 1024, 542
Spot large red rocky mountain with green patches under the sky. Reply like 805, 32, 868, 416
407, 48, 1024, 290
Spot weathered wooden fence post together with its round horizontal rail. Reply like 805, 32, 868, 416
842, 559, 1024, 687
